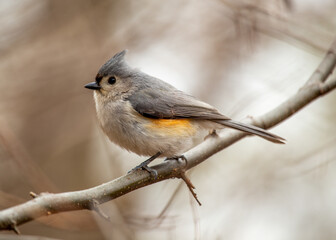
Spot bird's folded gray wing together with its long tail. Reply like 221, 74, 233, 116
124, 85, 285, 144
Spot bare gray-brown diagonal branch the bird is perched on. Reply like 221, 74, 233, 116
0, 40, 336, 231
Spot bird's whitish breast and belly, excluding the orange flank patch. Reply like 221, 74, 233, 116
95, 92, 211, 157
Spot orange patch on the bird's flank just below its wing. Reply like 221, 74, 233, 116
148, 119, 196, 137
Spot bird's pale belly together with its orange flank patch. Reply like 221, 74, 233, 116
97, 102, 201, 157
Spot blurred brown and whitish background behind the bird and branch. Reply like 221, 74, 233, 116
0, 0, 336, 240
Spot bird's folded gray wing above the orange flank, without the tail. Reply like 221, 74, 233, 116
128, 88, 229, 120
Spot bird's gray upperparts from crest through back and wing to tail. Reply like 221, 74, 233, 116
97, 50, 284, 143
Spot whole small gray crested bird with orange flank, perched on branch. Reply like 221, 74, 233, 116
85, 50, 284, 176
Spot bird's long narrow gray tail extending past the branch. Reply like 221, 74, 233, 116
216, 120, 286, 144
